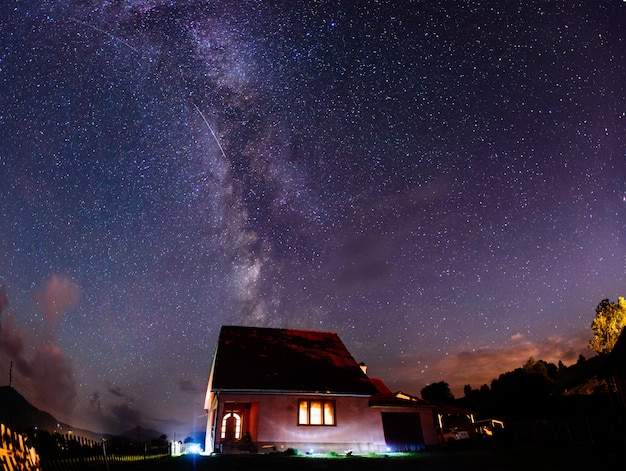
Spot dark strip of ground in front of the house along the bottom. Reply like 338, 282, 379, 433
118, 447, 626, 471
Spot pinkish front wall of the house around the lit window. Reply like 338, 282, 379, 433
215, 393, 386, 453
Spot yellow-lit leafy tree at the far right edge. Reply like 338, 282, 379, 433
589, 296, 626, 354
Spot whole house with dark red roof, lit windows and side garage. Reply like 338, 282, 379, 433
205, 326, 437, 453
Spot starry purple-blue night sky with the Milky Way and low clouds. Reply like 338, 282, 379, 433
0, 0, 626, 439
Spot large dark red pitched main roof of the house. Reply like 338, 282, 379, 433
207, 326, 377, 395
